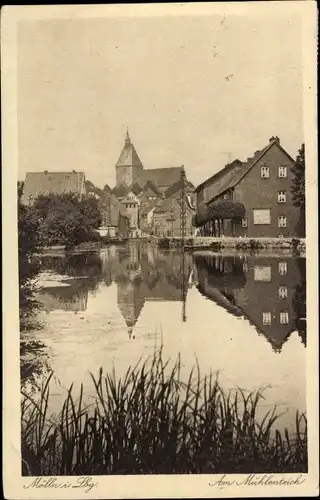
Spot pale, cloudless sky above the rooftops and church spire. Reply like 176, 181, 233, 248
17, 14, 304, 187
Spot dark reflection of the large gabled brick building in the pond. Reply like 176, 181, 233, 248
194, 254, 306, 352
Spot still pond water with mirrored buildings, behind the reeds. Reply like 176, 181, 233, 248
22, 242, 306, 429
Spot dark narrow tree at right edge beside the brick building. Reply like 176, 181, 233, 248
291, 144, 306, 237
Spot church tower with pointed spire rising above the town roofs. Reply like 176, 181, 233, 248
116, 130, 143, 187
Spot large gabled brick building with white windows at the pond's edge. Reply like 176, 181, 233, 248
195, 137, 299, 238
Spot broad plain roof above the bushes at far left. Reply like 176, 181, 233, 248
22, 172, 85, 203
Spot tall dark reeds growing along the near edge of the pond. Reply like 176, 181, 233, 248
21, 351, 307, 475
